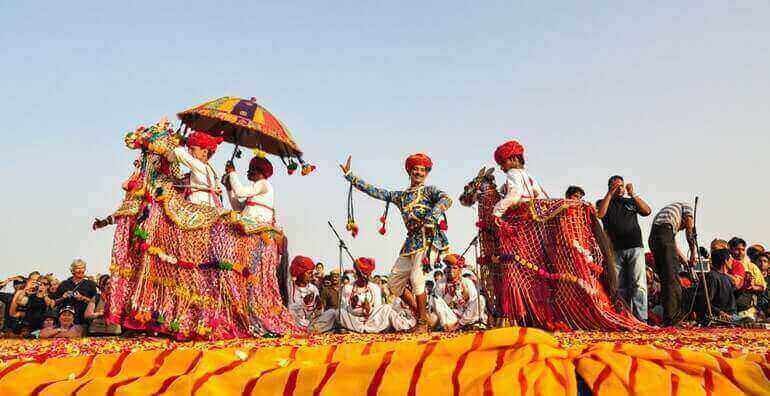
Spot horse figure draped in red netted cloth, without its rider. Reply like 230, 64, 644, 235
460, 168, 647, 331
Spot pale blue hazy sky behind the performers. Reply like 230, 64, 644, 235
0, 1, 770, 277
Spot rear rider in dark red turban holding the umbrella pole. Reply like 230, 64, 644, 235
225, 157, 275, 224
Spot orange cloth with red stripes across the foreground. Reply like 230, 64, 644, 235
0, 328, 770, 396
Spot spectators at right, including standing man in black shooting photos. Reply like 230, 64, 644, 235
565, 175, 770, 328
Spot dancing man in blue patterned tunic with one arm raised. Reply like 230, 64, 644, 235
340, 153, 452, 332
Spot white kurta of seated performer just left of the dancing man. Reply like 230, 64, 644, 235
340, 282, 393, 333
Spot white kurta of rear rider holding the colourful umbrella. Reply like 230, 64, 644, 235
227, 172, 275, 223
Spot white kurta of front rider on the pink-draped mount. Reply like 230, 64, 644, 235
172, 147, 222, 207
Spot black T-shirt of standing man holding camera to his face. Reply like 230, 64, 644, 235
596, 197, 644, 250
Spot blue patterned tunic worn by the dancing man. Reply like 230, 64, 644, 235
345, 173, 452, 256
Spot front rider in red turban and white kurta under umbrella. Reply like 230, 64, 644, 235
167, 132, 222, 208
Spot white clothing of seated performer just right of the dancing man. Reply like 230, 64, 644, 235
431, 278, 487, 327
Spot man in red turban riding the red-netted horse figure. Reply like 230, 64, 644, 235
492, 140, 547, 217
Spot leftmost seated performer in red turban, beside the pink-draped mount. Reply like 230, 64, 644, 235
289, 256, 336, 333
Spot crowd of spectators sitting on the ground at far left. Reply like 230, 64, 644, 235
0, 259, 121, 338
